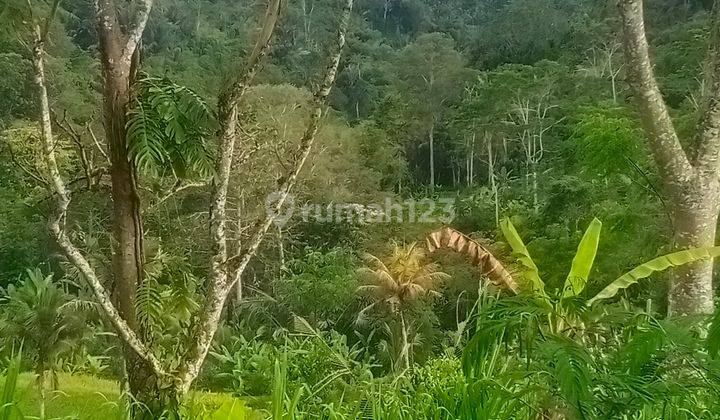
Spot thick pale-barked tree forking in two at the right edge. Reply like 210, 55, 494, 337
619, 0, 720, 315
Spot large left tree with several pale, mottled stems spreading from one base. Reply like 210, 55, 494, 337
32, 0, 353, 418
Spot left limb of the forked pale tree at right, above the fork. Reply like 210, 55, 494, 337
618, 0, 693, 187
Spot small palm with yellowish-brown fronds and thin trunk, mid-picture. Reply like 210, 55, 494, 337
358, 242, 449, 369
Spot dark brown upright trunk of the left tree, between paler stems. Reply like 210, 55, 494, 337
97, 0, 162, 418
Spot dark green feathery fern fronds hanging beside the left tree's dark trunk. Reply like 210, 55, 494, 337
127, 76, 213, 178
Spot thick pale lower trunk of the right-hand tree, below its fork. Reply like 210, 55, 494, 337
668, 178, 720, 316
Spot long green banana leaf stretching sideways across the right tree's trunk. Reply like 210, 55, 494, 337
588, 246, 720, 305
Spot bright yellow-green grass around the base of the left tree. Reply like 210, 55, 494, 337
0, 373, 263, 420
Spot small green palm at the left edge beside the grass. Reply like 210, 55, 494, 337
0, 268, 87, 419
